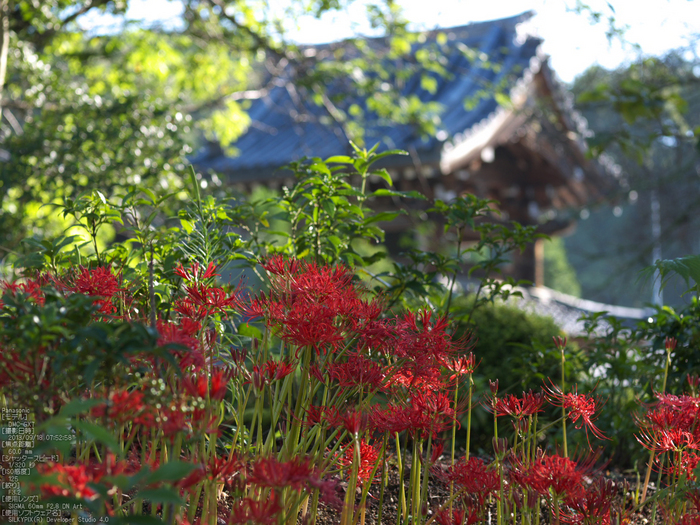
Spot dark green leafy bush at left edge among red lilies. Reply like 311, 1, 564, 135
0, 289, 162, 421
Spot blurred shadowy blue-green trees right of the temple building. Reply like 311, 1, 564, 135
565, 51, 700, 306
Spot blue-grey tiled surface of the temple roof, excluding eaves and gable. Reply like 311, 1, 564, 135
192, 13, 541, 182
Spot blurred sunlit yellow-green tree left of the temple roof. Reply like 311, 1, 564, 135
0, 0, 442, 250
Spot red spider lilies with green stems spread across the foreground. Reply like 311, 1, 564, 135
0, 256, 680, 525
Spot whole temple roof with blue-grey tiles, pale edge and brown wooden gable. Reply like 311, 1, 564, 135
192, 12, 611, 217
